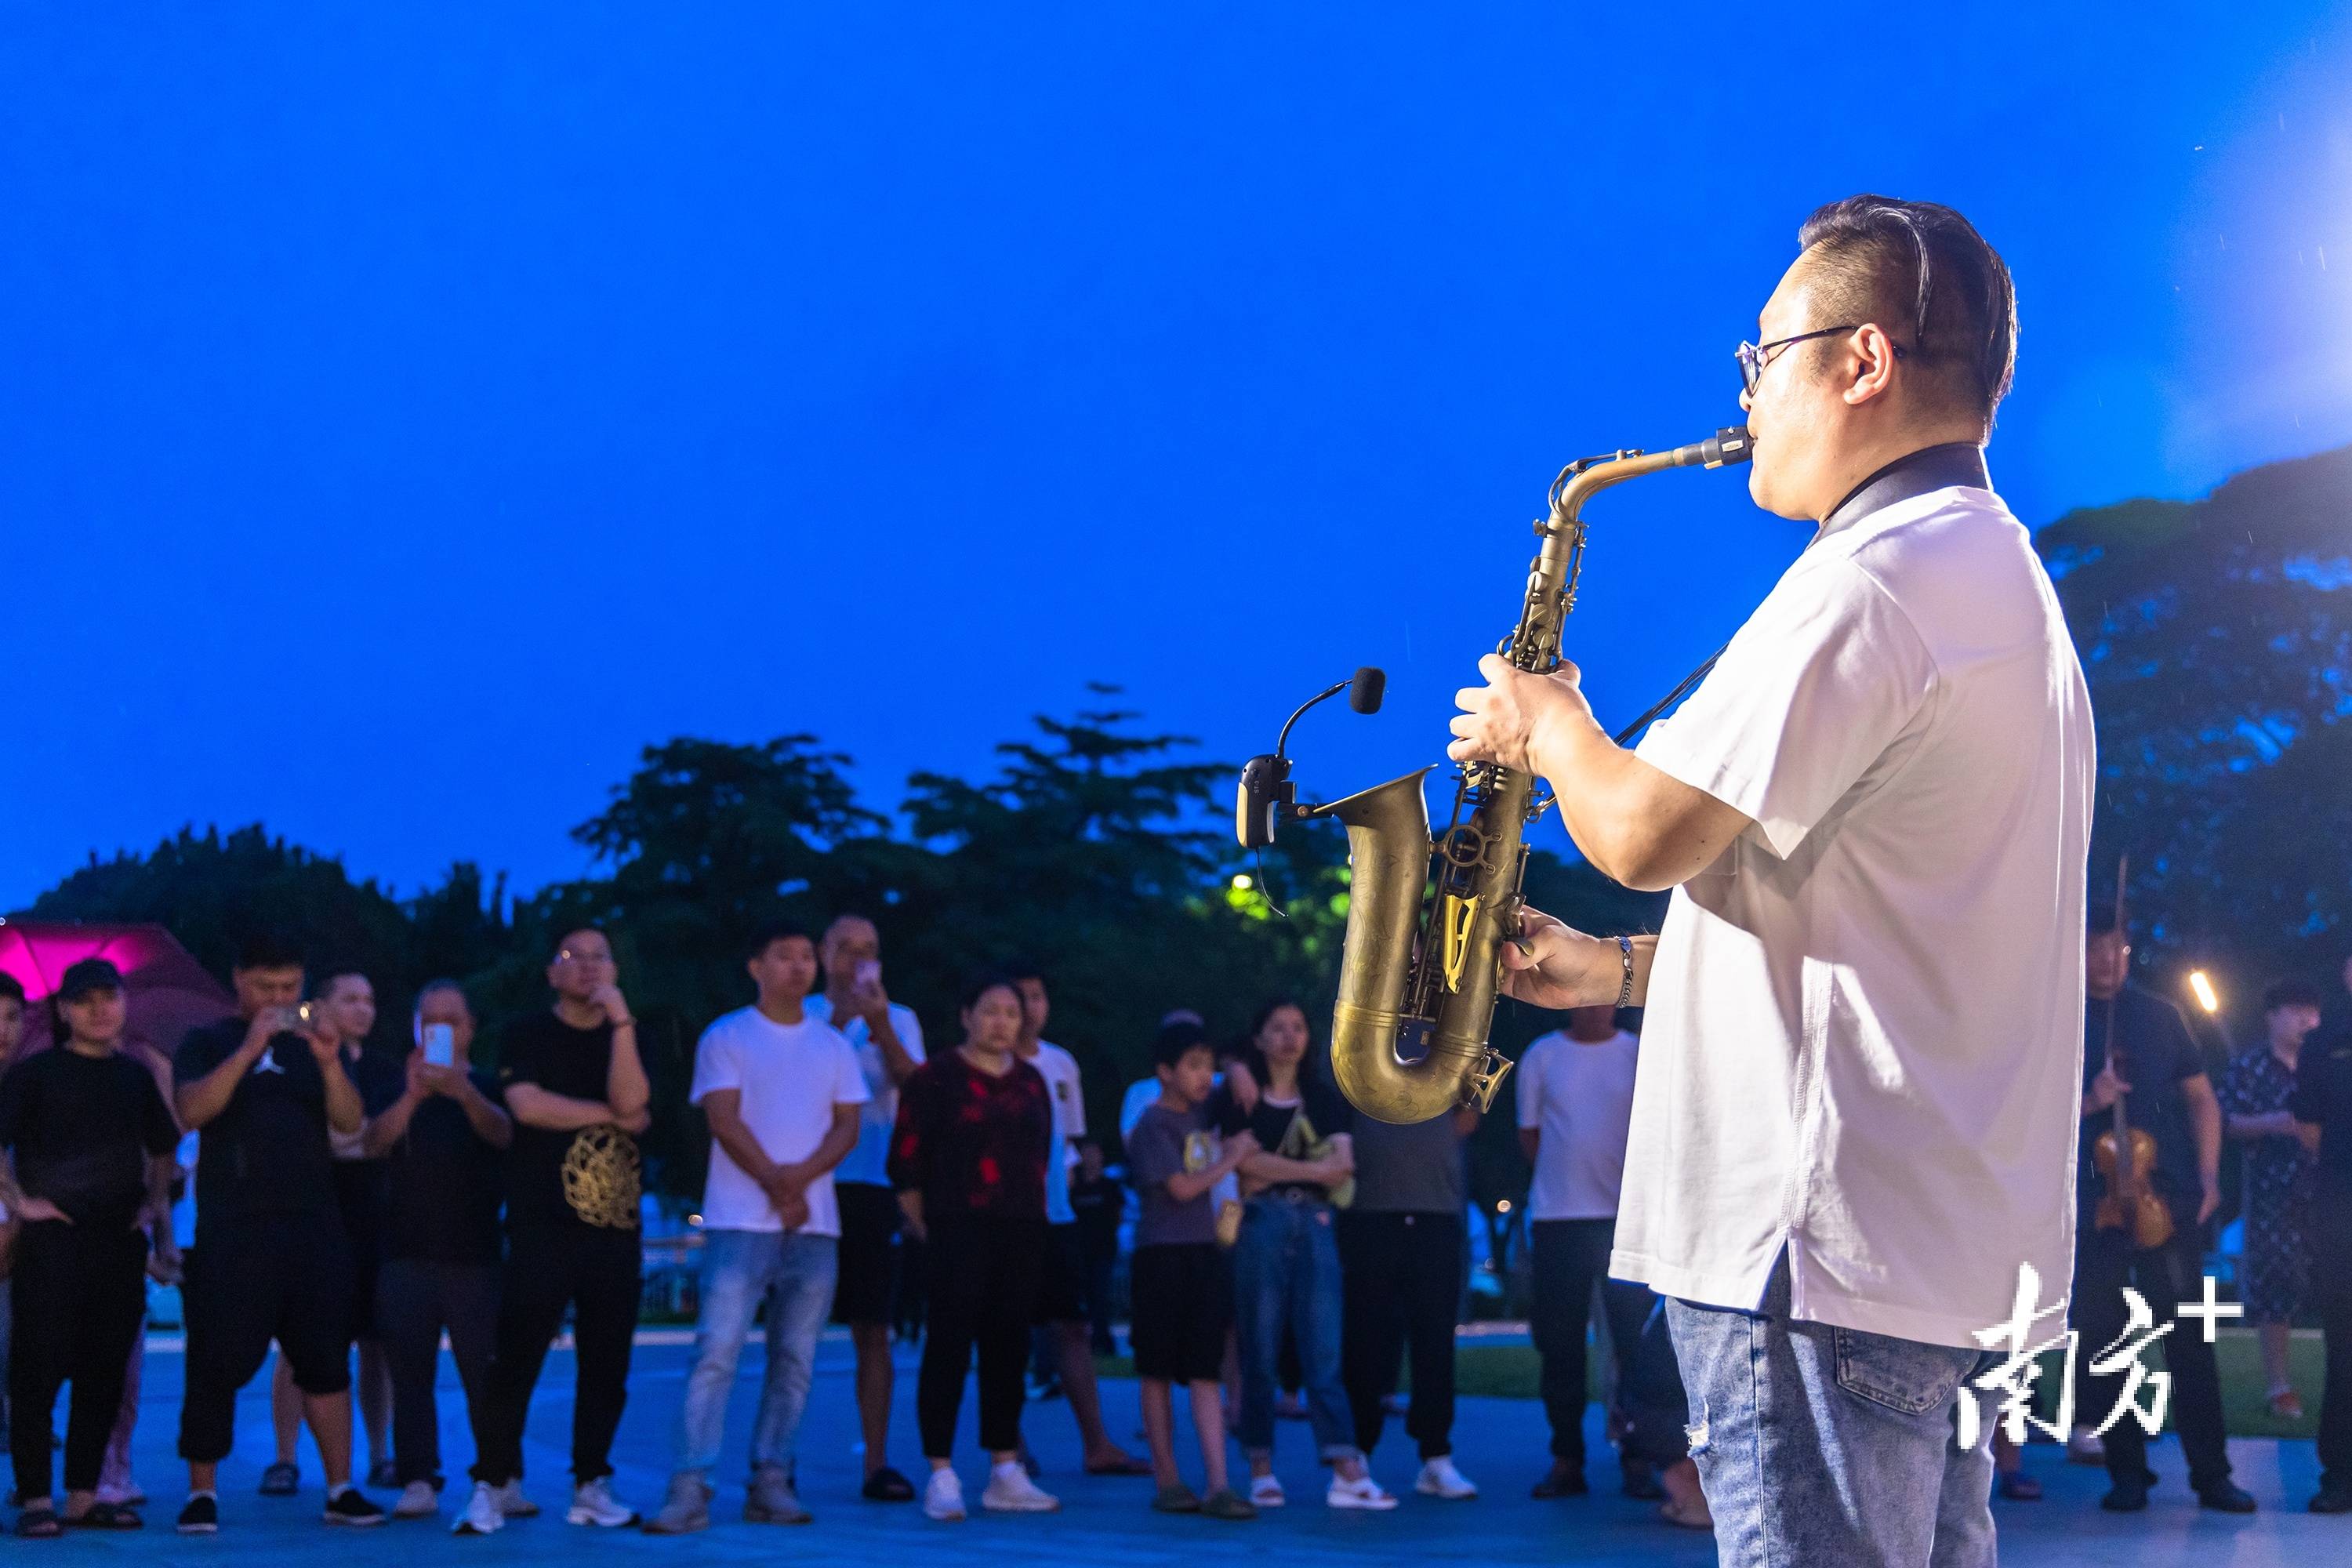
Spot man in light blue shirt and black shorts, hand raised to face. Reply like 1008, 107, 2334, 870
807, 914, 922, 1502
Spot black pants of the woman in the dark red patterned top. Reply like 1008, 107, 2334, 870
915, 1215, 1044, 1460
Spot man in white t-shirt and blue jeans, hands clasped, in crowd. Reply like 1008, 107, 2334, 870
644, 926, 870, 1535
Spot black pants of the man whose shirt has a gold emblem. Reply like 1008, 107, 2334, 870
468, 1218, 644, 1486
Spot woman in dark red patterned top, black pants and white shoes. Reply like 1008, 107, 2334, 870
889, 975, 1061, 1519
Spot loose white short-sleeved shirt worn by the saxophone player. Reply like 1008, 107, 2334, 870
1611, 487, 2093, 1347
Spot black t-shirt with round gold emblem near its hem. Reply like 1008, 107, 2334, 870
499, 1011, 640, 1229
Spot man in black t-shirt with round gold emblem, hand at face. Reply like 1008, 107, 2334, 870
456, 926, 652, 1535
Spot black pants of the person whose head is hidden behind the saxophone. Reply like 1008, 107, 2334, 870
1338, 1210, 1468, 1460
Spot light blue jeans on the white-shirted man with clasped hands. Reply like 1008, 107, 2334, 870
677, 1229, 840, 1481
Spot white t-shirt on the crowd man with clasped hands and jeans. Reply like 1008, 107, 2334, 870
687, 1006, 870, 1236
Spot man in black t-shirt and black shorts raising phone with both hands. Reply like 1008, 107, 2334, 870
172, 938, 383, 1535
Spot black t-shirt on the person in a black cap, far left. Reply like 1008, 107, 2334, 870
0, 1046, 179, 1229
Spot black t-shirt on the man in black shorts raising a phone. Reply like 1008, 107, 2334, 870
172, 1018, 336, 1227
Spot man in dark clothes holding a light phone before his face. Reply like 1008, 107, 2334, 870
365, 980, 515, 1528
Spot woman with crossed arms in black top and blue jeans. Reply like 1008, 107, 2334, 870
1216, 999, 1397, 1509
